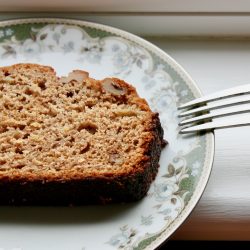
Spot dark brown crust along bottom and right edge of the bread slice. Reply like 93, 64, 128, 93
0, 65, 164, 205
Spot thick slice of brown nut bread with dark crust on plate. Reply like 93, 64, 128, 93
0, 64, 164, 205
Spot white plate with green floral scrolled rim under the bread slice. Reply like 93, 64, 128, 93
0, 19, 214, 250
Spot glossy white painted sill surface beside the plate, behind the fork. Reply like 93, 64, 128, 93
147, 37, 250, 240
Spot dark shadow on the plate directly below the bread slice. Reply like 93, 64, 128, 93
0, 202, 141, 226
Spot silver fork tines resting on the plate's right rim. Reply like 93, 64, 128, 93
178, 84, 250, 134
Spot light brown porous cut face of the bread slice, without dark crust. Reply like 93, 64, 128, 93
0, 64, 162, 181
